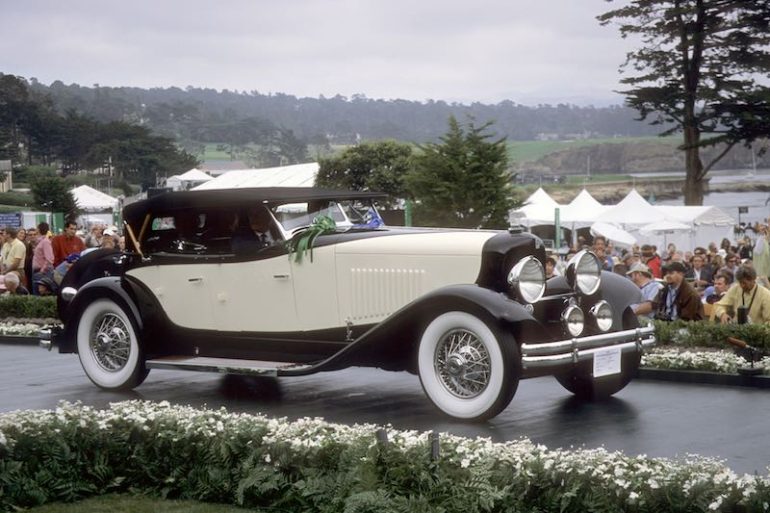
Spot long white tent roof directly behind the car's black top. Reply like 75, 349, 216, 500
193, 162, 318, 190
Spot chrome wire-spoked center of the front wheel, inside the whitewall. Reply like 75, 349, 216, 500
433, 329, 491, 399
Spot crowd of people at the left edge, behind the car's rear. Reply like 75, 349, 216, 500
0, 220, 124, 296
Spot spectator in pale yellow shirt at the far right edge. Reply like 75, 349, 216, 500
715, 265, 770, 324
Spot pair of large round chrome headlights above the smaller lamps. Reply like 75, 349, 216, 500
508, 250, 602, 303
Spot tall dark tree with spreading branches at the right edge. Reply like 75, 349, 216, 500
598, 0, 770, 205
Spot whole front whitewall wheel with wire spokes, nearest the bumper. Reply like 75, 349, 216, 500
417, 312, 521, 421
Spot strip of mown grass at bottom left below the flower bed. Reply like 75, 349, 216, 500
27, 495, 249, 513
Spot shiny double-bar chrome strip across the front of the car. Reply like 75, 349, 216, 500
521, 326, 655, 368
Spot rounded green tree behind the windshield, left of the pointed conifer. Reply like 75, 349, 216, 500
316, 141, 412, 206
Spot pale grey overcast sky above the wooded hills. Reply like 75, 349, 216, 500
0, 0, 630, 106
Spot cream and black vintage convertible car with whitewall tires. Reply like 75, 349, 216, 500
41, 188, 655, 420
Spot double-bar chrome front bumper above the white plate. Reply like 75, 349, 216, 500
521, 326, 655, 369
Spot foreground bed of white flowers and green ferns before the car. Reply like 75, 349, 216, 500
0, 401, 770, 513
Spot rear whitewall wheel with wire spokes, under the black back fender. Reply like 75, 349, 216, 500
77, 299, 149, 390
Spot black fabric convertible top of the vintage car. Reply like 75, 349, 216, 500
123, 187, 387, 224
